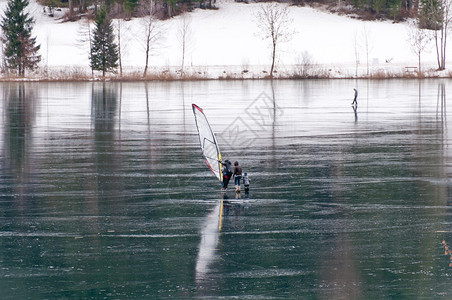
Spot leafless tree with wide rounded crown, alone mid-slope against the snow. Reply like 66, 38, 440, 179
255, 2, 295, 77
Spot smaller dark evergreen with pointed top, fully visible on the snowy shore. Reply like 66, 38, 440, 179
90, 9, 119, 76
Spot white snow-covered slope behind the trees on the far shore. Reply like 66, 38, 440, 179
0, 0, 452, 79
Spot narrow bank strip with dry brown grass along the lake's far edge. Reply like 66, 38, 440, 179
0, 65, 452, 82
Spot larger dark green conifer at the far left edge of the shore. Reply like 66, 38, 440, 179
1, 0, 41, 76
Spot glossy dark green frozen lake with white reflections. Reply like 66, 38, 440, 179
0, 80, 452, 299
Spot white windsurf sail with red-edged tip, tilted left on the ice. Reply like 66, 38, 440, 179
192, 104, 223, 181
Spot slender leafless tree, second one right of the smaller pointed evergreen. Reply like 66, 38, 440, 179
140, 0, 162, 77
